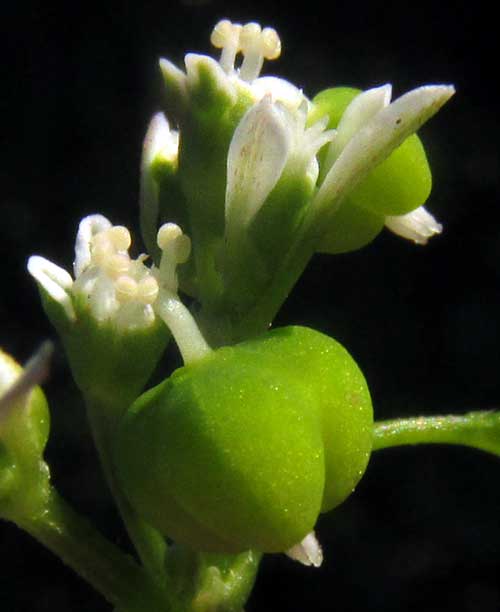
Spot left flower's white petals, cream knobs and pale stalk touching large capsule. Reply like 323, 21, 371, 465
28, 215, 210, 363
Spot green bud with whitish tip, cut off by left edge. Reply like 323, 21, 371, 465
0, 350, 50, 521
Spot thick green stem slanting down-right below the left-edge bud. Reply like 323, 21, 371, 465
15, 489, 162, 611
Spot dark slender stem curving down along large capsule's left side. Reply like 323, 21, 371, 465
86, 397, 167, 582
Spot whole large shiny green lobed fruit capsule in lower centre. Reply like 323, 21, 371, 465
115, 327, 372, 552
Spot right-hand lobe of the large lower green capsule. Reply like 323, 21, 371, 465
233, 326, 373, 512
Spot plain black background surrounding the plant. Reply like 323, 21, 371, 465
0, 0, 500, 612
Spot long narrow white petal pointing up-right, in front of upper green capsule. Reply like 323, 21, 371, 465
311, 85, 455, 220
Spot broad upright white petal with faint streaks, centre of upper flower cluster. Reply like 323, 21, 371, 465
225, 96, 292, 235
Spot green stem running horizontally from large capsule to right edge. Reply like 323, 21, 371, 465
373, 411, 500, 456
